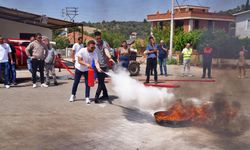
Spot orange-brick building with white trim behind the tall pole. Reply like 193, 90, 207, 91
147, 5, 235, 32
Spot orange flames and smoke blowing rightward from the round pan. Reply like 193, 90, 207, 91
155, 100, 240, 123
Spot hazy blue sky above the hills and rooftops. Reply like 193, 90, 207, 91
0, 0, 246, 22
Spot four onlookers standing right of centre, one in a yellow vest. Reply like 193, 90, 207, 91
144, 36, 213, 84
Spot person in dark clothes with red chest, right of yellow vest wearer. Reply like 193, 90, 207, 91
201, 44, 213, 79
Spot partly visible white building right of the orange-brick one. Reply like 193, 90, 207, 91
234, 10, 250, 38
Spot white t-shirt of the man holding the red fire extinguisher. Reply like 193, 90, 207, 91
75, 47, 98, 72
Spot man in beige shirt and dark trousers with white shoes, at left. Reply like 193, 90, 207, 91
25, 33, 48, 88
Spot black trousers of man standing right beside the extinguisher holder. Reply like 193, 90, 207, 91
95, 67, 108, 99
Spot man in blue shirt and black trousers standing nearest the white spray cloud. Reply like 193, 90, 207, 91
144, 37, 158, 84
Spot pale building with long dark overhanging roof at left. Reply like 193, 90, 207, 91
0, 6, 82, 39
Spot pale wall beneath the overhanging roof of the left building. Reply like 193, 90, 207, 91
0, 18, 52, 39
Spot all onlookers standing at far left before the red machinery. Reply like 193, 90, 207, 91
0, 33, 58, 88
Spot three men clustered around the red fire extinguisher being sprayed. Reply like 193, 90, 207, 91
69, 31, 114, 104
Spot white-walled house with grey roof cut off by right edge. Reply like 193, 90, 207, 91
235, 12, 250, 38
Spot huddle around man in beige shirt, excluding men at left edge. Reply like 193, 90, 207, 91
25, 33, 58, 88
